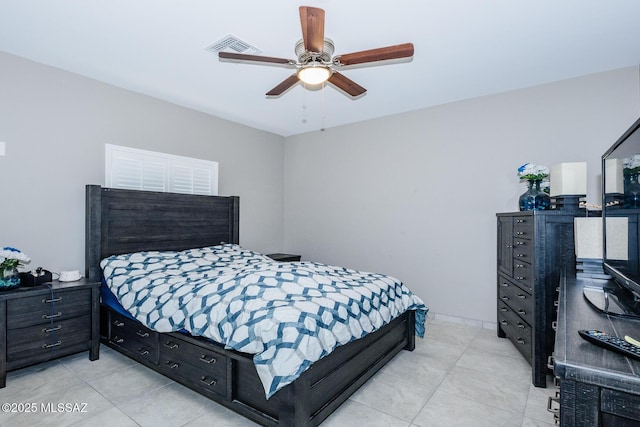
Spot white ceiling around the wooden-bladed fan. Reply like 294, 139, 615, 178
0, 0, 640, 136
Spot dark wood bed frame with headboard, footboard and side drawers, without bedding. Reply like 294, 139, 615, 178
85, 185, 426, 426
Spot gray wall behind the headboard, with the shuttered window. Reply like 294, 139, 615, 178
0, 53, 284, 271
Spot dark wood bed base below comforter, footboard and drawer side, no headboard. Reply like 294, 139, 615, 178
100, 306, 415, 427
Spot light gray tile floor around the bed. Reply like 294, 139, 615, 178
0, 318, 555, 427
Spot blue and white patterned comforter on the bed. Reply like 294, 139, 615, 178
100, 245, 427, 398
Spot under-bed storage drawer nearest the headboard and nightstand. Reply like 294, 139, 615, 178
108, 311, 158, 363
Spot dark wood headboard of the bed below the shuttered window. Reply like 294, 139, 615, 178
85, 185, 240, 281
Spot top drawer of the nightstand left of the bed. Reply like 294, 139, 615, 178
7, 289, 91, 329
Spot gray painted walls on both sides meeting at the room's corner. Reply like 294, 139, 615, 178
0, 49, 640, 323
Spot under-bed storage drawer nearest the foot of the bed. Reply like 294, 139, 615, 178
159, 334, 228, 396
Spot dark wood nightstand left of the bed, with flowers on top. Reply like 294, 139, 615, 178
0, 279, 100, 388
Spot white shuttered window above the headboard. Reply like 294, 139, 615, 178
105, 144, 218, 196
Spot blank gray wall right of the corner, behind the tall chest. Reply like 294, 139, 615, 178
284, 67, 640, 326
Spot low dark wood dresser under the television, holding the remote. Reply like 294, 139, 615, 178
549, 274, 640, 427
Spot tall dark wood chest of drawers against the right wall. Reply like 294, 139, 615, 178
497, 210, 584, 387
